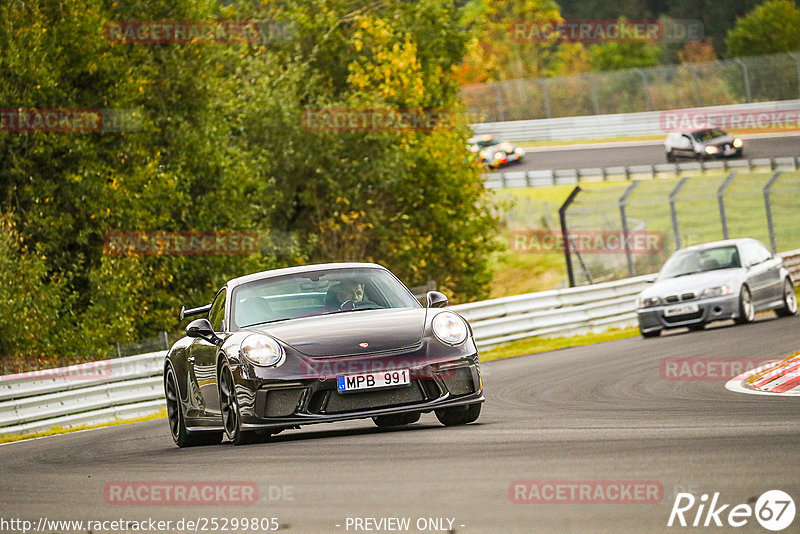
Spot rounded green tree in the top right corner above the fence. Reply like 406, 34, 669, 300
725, 0, 800, 57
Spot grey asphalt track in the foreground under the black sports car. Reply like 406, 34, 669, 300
0, 313, 800, 534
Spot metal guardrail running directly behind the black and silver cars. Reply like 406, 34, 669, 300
0, 249, 800, 436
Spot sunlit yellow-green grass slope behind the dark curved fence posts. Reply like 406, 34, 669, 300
490, 172, 800, 298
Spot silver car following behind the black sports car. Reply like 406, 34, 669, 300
637, 239, 797, 337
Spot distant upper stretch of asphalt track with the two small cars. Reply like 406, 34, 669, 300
500, 135, 800, 172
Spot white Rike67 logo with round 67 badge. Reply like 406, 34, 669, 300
667, 490, 795, 532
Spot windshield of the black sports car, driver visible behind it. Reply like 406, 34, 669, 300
231, 268, 420, 328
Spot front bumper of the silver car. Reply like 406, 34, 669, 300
636, 295, 739, 333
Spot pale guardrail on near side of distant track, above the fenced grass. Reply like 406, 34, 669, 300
484, 156, 800, 189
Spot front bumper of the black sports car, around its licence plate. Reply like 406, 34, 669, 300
235, 354, 485, 430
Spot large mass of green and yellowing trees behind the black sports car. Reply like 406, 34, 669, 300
0, 0, 497, 357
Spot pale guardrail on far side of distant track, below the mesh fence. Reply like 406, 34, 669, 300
472, 100, 800, 142
